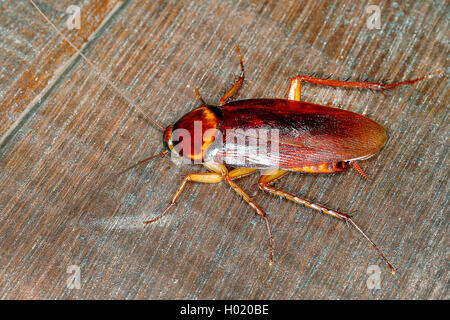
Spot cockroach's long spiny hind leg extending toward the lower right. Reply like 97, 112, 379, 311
258, 169, 395, 274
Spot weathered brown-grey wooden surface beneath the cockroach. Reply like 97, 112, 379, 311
0, 0, 450, 299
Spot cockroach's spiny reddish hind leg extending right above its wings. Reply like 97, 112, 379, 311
288, 76, 431, 101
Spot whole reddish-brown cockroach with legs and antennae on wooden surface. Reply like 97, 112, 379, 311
30, 0, 438, 274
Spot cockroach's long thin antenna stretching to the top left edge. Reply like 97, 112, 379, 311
29, 0, 164, 131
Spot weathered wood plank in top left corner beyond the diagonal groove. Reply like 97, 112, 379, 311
0, 0, 121, 146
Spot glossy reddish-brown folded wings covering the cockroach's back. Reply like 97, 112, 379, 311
214, 99, 386, 169
